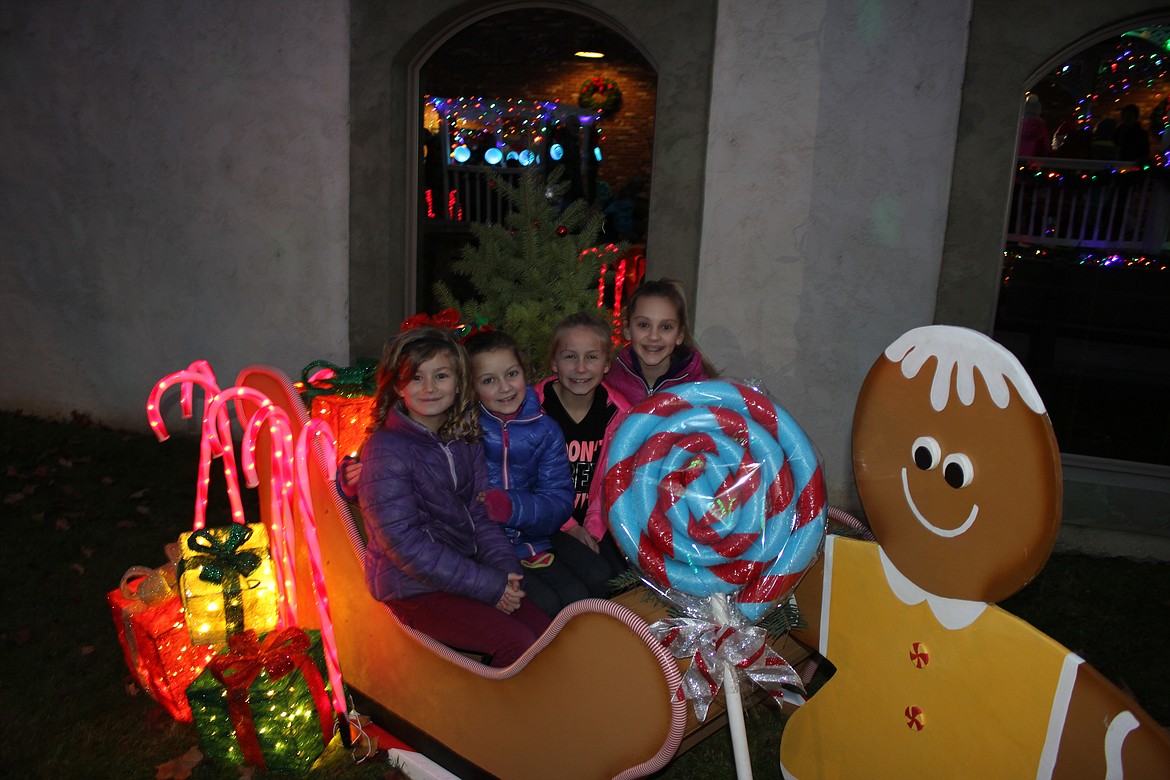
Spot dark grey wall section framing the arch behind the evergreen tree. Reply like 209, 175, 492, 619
349, 0, 716, 358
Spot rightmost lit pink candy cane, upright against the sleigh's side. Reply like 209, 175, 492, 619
296, 420, 345, 716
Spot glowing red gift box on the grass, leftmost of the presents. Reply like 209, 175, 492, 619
106, 567, 215, 723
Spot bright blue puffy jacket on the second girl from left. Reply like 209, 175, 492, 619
479, 387, 574, 558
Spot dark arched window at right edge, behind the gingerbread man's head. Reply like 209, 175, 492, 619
993, 23, 1170, 467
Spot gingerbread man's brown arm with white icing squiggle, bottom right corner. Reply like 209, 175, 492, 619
1052, 663, 1170, 780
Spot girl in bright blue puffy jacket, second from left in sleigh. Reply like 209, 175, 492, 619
464, 330, 611, 617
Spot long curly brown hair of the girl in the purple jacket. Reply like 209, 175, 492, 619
370, 327, 483, 442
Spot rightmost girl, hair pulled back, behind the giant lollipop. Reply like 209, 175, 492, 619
605, 278, 718, 406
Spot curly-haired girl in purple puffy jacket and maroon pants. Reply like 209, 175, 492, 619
358, 327, 549, 667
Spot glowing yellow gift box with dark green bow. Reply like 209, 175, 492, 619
179, 523, 278, 644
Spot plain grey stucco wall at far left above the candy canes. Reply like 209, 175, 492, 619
0, 0, 349, 428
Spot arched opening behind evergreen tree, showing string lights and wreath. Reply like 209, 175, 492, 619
414, 7, 658, 311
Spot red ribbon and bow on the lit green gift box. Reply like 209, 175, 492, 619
208, 628, 333, 768
